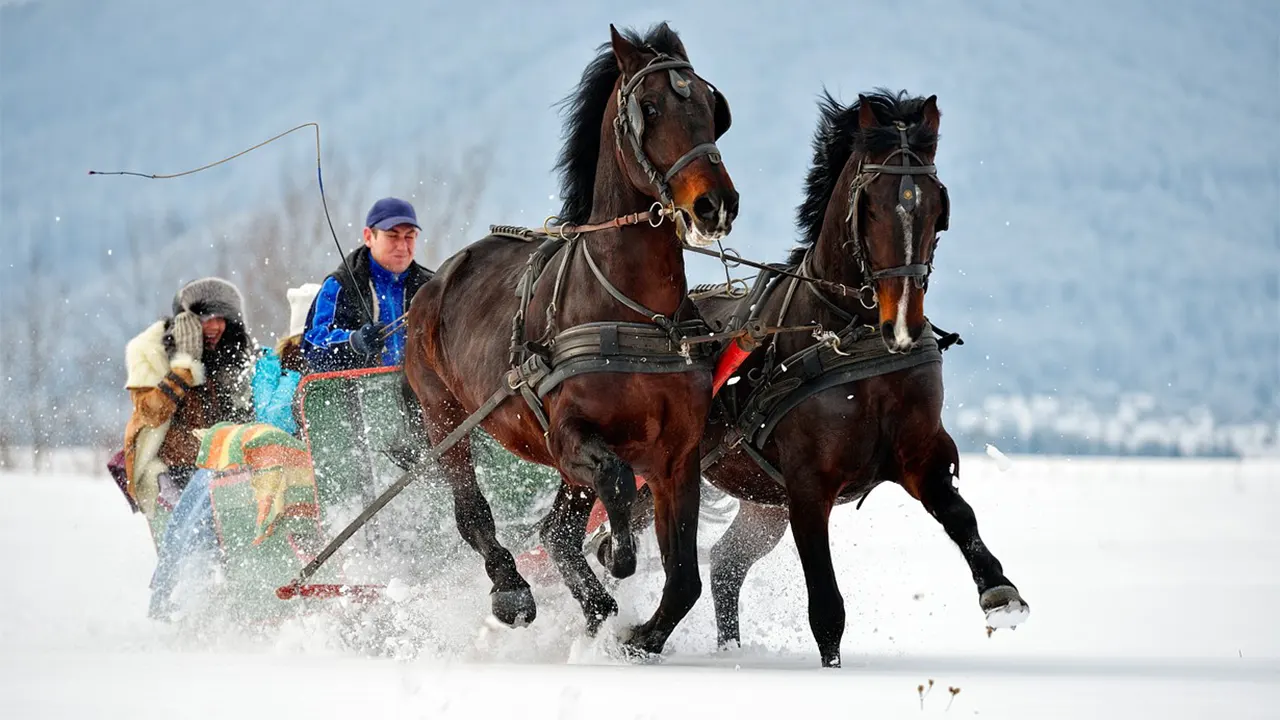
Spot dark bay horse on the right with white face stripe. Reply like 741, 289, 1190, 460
599, 91, 1029, 666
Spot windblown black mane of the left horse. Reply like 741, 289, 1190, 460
556, 23, 689, 224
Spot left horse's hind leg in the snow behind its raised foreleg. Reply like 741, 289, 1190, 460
541, 482, 618, 637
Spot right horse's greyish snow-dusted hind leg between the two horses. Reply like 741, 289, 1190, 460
712, 500, 787, 648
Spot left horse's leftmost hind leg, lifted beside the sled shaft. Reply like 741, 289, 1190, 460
422, 377, 538, 625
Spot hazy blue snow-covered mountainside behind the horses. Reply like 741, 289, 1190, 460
0, 0, 1280, 448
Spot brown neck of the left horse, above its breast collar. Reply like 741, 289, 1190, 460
579, 143, 687, 316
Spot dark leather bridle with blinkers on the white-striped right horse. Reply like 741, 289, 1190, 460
845, 120, 951, 304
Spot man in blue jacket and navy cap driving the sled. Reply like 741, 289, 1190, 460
302, 197, 434, 373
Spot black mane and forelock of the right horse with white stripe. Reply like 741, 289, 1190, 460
787, 87, 938, 265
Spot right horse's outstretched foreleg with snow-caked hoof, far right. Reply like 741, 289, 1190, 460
909, 436, 1030, 628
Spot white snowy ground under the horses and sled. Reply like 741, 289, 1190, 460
0, 456, 1280, 720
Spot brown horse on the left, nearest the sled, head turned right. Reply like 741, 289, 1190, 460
404, 23, 739, 652
